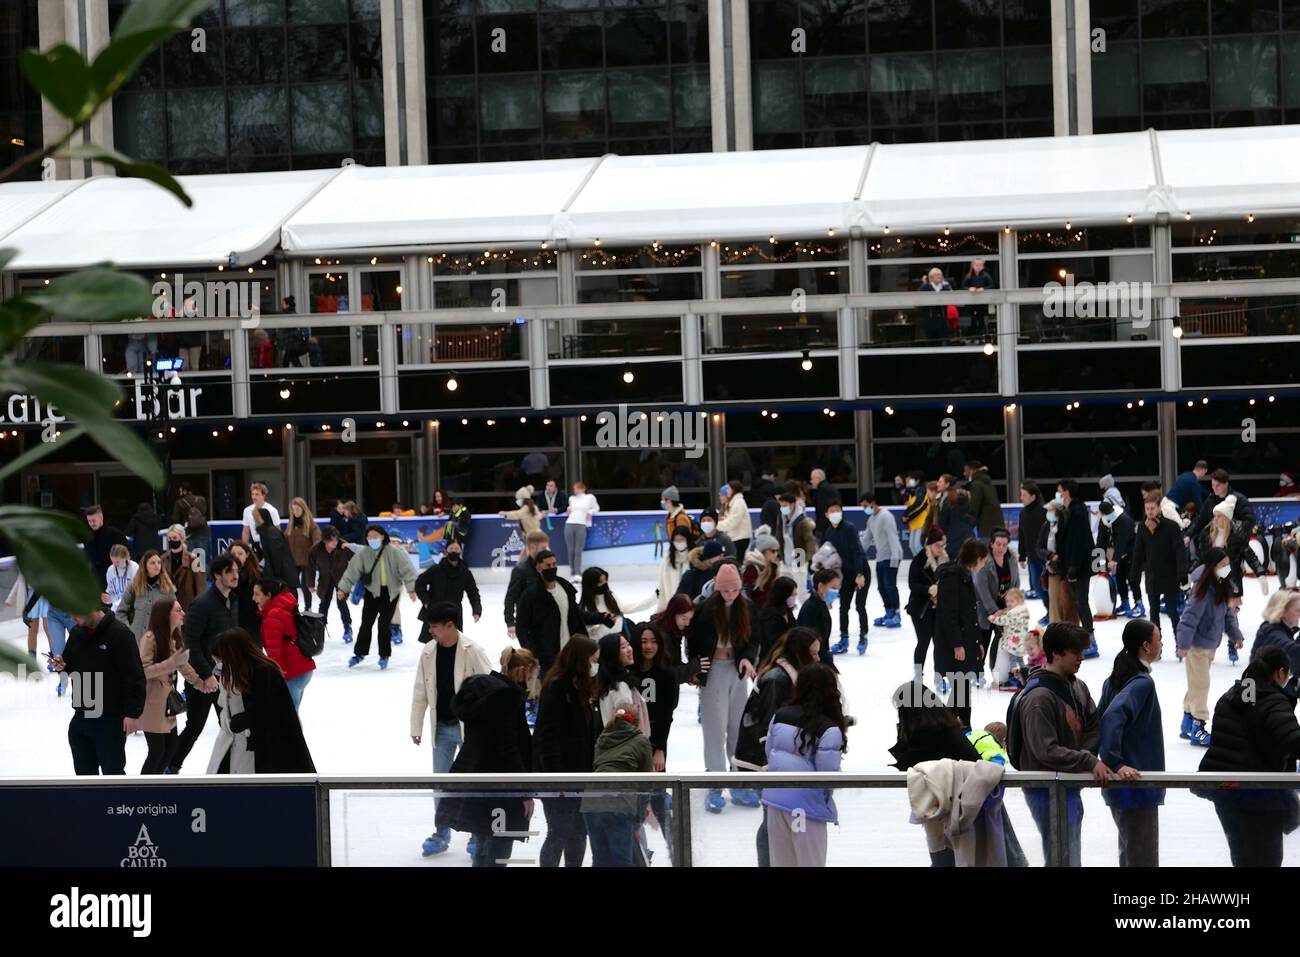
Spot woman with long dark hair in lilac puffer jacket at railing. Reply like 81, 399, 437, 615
762, 662, 849, 867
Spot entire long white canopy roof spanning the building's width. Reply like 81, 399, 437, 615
0, 126, 1300, 270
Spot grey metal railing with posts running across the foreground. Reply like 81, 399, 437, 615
0, 771, 1300, 867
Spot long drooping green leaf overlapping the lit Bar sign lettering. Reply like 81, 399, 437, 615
0, 363, 166, 489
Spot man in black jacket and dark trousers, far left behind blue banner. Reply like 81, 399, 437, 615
51, 607, 146, 775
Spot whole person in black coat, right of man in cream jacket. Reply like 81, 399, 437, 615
434, 642, 538, 867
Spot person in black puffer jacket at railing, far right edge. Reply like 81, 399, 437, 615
1192, 646, 1300, 867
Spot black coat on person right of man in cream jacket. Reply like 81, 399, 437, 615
436, 670, 533, 835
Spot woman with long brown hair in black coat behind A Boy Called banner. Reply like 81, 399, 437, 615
208, 628, 316, 774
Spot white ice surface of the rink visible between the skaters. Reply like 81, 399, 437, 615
0, 555, 1295, 867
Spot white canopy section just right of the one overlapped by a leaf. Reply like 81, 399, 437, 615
283, 157, 601, 255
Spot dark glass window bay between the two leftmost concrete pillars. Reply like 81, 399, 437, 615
109, 0, 384, 174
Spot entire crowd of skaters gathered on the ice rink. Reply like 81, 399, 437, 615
8, 462, 1300, 866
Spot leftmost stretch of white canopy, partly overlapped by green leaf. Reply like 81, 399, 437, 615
0, 169, 339, 270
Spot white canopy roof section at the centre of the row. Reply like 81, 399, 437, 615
555, 146, 871, 243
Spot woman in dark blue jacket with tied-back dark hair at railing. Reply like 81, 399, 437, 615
1097, 618, 1165, 867
